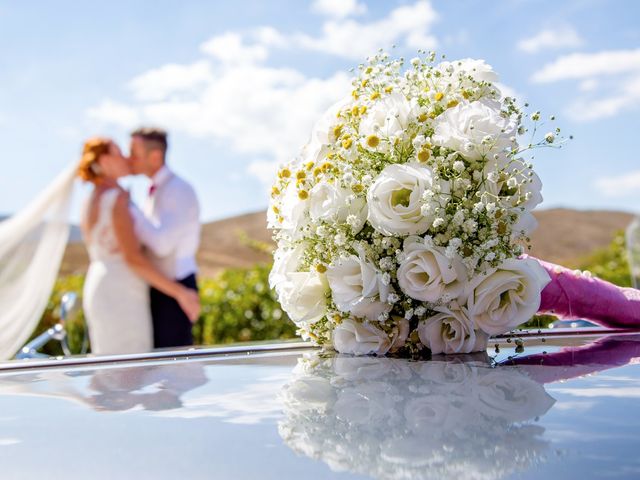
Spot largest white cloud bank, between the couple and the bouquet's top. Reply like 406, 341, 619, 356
88, 0, 437, 183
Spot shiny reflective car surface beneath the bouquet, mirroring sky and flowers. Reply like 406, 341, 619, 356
0, 330, 640, 479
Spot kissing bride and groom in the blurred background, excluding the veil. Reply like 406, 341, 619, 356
77, 128, 200, 354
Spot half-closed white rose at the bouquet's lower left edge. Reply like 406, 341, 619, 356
276, 272, 329, 327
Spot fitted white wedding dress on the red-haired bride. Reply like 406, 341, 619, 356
83, 188, 153, 355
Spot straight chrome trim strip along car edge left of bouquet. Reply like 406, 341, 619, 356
0, 341, 318, 373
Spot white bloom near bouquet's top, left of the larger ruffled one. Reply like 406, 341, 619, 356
360, 92, 413, 139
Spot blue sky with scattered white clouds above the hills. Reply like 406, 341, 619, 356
0, 0, 640, 220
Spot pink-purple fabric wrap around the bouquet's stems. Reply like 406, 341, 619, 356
531, 253, 640, 328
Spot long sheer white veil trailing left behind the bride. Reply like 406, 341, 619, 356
0, 168, 76, 360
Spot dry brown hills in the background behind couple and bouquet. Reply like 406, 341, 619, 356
61, 208, 632, 276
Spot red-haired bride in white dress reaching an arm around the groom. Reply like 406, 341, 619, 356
78, 138, 200, 354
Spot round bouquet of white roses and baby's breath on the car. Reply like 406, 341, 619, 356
268, 53, 559, 355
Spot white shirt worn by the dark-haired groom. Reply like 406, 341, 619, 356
135, 166, 201, 280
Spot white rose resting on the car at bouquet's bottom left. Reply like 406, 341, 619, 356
331, 318, 391, 355
